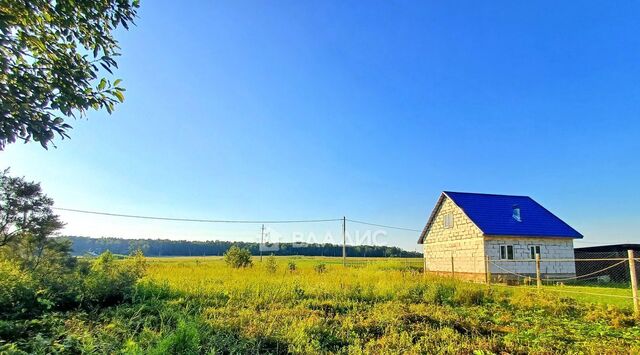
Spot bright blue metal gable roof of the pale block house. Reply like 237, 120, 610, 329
443, 191, 582, 238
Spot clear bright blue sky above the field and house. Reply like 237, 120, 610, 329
0, 0, 640, 250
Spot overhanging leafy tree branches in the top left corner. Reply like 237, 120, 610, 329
0, 0, 139, 150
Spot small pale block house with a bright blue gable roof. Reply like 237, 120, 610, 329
418, 191, 582, 281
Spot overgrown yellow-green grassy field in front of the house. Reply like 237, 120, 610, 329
1, 258, 640, 354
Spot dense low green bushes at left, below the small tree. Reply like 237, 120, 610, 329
0, 253, 146, 353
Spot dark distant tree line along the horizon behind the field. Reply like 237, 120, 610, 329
57, 236, 422, 258
